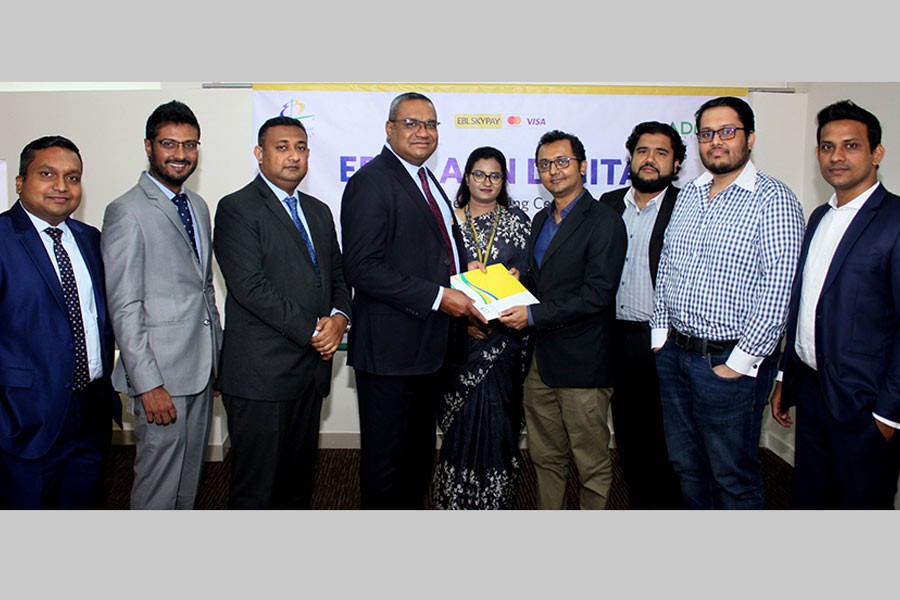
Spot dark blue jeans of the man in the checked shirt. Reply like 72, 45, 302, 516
656, 340, 778, 510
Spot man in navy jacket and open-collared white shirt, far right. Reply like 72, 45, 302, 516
771, 100, 900, 509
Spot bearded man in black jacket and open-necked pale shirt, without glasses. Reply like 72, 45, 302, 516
600, 121, 687, 509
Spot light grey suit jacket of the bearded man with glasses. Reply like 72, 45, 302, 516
100, 171, 222, 396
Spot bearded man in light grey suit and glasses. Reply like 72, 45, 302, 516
101, 100, 222, 509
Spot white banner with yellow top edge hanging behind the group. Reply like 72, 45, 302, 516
251, 84, 747, 236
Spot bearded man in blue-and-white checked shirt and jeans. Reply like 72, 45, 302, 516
650, 97, 804, 509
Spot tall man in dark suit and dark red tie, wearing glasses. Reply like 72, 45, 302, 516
341, 92, 483, 509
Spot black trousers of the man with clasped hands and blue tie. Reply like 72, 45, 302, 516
222, 382, 322, 510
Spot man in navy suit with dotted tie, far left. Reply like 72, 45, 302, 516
0, 136, 122, 509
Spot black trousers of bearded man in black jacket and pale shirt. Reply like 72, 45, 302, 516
610, 320, 681, 509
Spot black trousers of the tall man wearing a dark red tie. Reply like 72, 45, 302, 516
356, 371, 446, 510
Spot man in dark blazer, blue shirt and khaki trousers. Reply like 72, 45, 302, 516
500, 131, 627, 509
